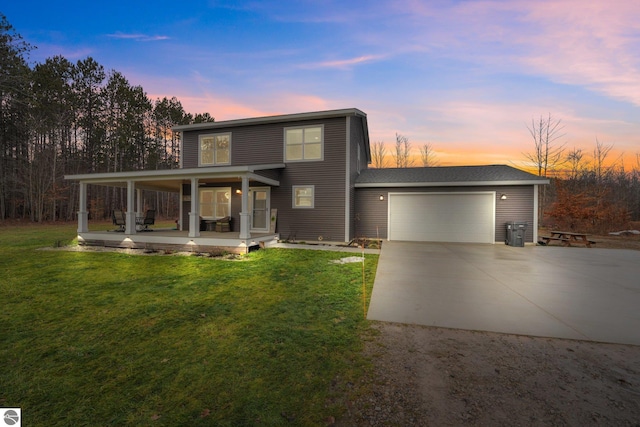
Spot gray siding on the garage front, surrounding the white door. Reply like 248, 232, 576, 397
355, 185, 534, 242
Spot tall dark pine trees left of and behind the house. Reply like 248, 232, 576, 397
0, 14, 213, 221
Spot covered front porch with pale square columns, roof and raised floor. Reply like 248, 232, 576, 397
65, 164, 284, 252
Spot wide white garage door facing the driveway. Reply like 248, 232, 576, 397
388, 192, 495, 243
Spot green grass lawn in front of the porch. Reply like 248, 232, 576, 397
0, 224, 378, 426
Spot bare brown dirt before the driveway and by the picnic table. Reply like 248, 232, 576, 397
336, 236, 640, 426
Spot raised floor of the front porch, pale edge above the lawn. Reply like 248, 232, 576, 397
78, 228, 279, 253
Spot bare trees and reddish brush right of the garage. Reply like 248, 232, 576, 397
524, 114, 640, 233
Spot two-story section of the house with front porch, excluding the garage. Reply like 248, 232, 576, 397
66, 108, 370, 252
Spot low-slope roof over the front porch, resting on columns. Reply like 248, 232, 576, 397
64, 163, 285, 192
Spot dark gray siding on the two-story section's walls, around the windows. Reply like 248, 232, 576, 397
183, 117, 350, 242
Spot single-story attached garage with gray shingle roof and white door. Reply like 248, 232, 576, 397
353, 165, 549, 243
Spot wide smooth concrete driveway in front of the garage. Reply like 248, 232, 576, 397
367, 242, 640, 345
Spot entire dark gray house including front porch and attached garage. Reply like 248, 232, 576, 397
66, 108, 547, 251
